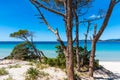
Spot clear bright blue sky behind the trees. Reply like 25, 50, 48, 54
0, 0, 120, 41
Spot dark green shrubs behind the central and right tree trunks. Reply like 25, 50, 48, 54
43, 46, 99, 69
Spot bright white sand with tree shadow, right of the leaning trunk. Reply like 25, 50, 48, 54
82, 61, 120, 80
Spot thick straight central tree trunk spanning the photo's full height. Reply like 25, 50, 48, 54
66, 0, 74, 80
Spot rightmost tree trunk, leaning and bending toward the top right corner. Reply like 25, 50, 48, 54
89, 0, 116, 77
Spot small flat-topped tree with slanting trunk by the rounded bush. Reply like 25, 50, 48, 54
10, 30, 46, 62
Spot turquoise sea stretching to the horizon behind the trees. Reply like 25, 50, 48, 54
0, 41, 120, 61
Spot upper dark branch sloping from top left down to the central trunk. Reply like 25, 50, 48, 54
30, 0, 65, 17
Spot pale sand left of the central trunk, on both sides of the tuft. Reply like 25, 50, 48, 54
0, 60, 67, 80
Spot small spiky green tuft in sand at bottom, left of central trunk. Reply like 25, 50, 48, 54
25, 67, 40, 80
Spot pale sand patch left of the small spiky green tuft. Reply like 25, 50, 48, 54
0, 60, 31, 80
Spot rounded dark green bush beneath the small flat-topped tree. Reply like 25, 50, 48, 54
5, 42, 37, 60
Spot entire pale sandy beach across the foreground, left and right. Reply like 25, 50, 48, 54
0, 60, 120, 80
